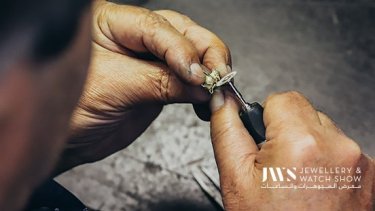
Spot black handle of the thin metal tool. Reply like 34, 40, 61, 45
240, 102, 266, 144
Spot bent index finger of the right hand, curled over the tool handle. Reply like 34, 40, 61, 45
263, 91, 320, 140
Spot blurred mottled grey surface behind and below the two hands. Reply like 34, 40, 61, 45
57, 0, 375, 210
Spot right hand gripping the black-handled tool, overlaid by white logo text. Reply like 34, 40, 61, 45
211, 91, 375, 211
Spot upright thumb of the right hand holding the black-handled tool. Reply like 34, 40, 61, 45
211, 90, 258, 173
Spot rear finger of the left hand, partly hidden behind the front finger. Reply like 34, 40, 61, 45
155, 10, 231, 76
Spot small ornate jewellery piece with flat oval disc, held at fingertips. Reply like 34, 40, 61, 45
202, 70, 237, 94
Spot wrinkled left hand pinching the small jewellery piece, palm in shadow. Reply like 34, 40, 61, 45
57, 1, 230, 172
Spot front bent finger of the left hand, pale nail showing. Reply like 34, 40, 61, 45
103, 5, 205, 85
